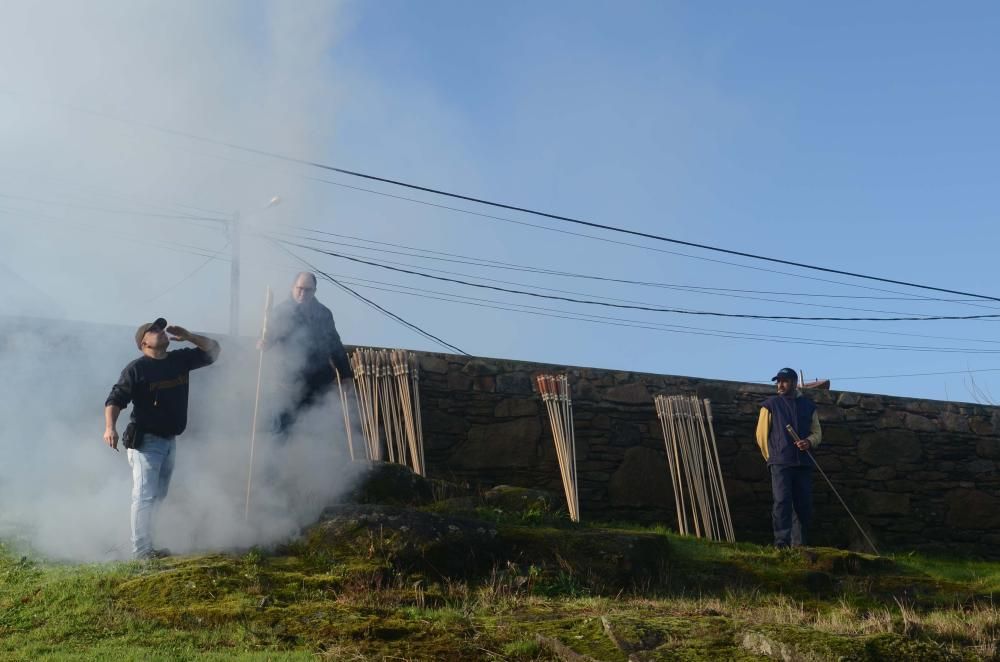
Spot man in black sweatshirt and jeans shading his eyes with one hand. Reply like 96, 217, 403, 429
104, 317, 220, 559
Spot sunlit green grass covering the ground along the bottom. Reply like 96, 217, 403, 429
0, 528, 1000, 661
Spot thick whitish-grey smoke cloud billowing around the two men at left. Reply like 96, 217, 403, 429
0, 0, 368, 560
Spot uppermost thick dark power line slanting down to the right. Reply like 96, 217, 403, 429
23, 95, 1000, 306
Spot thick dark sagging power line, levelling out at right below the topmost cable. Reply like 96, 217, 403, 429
275, 239, 1000, 322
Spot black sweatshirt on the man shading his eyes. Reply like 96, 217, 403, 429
104, 348, 214, 437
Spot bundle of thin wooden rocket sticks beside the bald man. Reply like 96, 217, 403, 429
351, 349, 424, 476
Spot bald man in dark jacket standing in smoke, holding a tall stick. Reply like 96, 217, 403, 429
260, 271, 354, 436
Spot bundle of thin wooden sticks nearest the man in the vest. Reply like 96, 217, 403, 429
655, 395, 736, 542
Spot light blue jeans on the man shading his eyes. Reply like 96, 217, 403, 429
128, 432, 176, 557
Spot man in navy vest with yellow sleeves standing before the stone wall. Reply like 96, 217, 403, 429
757, 368, 823, 547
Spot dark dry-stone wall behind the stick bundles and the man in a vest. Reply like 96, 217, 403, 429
406, 353, 1000, 558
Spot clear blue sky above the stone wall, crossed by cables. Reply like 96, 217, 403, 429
0, 0, 1000, 400
